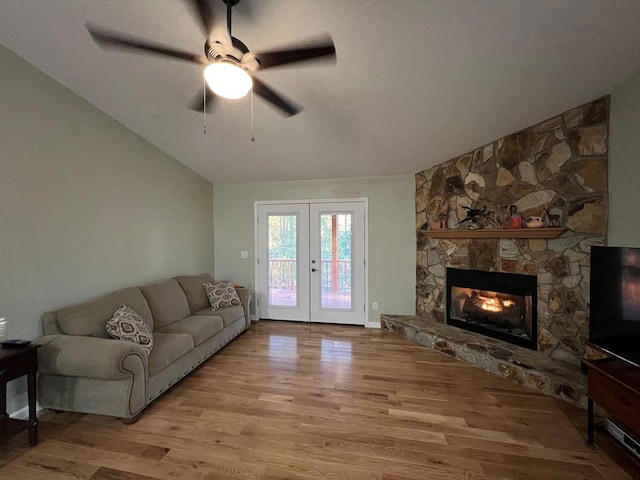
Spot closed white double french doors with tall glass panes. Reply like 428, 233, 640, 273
256, 201, 365, 325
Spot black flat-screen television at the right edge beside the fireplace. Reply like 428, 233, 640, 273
589, 247, 640, 367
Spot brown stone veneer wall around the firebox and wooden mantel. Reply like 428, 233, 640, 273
415, 97, 609, 371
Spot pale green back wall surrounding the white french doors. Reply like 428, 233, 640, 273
214, 175, 416, 322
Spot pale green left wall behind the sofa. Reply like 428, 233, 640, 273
0, 46, 213, 407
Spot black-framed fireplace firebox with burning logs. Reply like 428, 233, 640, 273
446, 268, 538, 350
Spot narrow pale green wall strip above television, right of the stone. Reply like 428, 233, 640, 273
607, 71, 640, 247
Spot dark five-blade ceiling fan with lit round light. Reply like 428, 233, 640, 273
87, 0, 336, 116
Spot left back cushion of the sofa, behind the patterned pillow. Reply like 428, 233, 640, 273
57, 287, 153, 338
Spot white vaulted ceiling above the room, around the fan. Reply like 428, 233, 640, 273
0, 0, 640, 183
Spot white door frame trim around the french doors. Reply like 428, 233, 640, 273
253, 197, 368, 327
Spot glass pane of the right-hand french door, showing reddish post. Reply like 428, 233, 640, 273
320, 213, 353, 310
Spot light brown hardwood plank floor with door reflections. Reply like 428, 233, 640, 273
0, 321, 631, 480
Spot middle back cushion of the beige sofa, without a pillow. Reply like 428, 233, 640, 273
140, 278, 191, 329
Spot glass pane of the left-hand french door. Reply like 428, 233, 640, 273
268, 214, 298, 307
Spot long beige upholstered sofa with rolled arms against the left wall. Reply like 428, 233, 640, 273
34, 274, 251, 422
